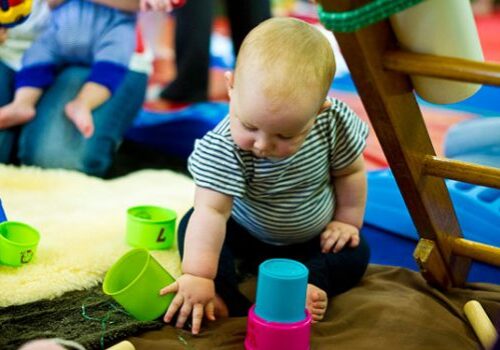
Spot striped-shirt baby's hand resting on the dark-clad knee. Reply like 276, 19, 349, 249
320, 221, 359, 253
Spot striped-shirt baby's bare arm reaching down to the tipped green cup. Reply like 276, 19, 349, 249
161, 186, 233, 334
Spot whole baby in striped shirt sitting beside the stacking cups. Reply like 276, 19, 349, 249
160, 18, 369, 333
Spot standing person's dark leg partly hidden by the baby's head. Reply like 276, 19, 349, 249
226, 0, 271, 55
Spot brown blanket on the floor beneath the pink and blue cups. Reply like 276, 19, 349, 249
129, 265, 500, 350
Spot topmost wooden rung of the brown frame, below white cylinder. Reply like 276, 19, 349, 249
383, 51, 500, 86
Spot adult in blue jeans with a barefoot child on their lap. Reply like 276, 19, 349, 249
0, 0, 151, 176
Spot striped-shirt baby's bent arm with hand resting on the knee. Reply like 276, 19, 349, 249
321, 155, 366, 253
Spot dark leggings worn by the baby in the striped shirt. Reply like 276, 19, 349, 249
178, 209, 370, 316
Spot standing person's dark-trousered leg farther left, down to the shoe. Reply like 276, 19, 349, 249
161, 0, 214, 102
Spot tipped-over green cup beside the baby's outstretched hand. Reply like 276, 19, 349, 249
102, 248, 175, 321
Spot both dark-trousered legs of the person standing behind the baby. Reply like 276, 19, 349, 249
160, 0, 271, 102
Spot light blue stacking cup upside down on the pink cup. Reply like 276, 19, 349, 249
255, 259, 309, 323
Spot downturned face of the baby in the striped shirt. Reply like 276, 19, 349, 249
229, 81, 318, 159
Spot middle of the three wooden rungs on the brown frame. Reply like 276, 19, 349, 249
423, 155, 500, 188
